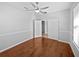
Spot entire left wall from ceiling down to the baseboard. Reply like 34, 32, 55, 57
0, 3, 32, 50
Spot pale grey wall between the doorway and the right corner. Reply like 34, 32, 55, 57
48, 9, 71, 42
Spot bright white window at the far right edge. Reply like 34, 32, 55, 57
74, 5, 79, 47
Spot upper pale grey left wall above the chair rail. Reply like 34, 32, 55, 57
0, 3, 32, 34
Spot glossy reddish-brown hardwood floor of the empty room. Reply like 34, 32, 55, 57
0, 37, 74, 57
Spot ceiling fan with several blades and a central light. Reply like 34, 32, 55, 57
24, 2, 49, 14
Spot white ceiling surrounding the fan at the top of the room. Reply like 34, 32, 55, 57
3, 2, 77, 12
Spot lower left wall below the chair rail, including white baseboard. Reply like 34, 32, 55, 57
0, 31, 32, 53
